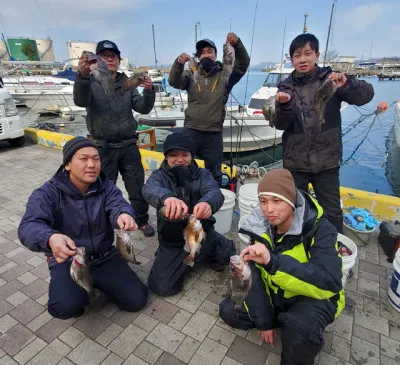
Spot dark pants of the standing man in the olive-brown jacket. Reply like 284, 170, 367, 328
184, 128, 224, 185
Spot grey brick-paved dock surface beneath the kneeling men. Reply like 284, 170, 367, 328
0, 143, 400, 365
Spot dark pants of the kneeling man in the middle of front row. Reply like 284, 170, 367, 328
148, 230, 236, 297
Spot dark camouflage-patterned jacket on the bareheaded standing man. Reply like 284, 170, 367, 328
274, 66, 374, 173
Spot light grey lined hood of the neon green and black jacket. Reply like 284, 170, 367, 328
239, 189, 323, 241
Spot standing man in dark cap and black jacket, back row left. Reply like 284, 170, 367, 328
74, 40, 155, 237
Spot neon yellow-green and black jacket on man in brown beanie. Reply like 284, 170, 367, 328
239, 190, 345, 331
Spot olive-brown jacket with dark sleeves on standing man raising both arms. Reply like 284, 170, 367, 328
168, 39, 250, 132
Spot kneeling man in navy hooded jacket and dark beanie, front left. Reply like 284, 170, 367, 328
18, 137, 148, 319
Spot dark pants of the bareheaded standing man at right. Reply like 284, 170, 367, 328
290, 167, 343, 234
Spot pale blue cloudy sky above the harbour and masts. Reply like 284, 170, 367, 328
0, 0, 400, 65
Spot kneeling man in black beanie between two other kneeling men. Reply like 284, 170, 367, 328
143, 132, 235, 296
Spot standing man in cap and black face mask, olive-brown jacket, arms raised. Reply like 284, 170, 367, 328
168, 33, 250, 185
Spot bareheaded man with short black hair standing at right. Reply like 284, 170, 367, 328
274, 34, 374, 233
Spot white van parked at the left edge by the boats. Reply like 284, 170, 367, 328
0, 83, 25, 147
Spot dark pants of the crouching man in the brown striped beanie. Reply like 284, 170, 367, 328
219, 298, 332, 365
